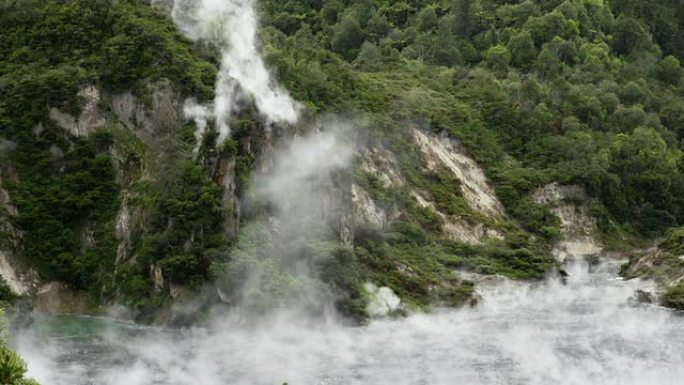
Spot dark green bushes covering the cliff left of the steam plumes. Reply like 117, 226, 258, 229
0, 1, 222, 312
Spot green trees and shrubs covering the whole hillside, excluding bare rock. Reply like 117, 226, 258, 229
0, 0, 684, 317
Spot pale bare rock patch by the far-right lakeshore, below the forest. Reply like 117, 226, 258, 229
534, 183, 602, 262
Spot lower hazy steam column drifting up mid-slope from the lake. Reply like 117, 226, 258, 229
218, 120, 354, 318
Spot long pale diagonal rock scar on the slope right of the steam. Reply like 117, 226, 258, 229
413, 129, 505, 218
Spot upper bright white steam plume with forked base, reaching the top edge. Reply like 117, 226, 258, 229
162, 0, 299, 143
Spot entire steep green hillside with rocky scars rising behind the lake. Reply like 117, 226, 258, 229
0, 0, 684, 323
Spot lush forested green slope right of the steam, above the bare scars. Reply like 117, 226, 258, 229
261, 0, 684, 236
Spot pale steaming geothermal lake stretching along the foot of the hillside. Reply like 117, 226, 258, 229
14, 262, 684, 385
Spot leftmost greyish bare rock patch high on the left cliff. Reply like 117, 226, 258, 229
49, 85, 105, 136
